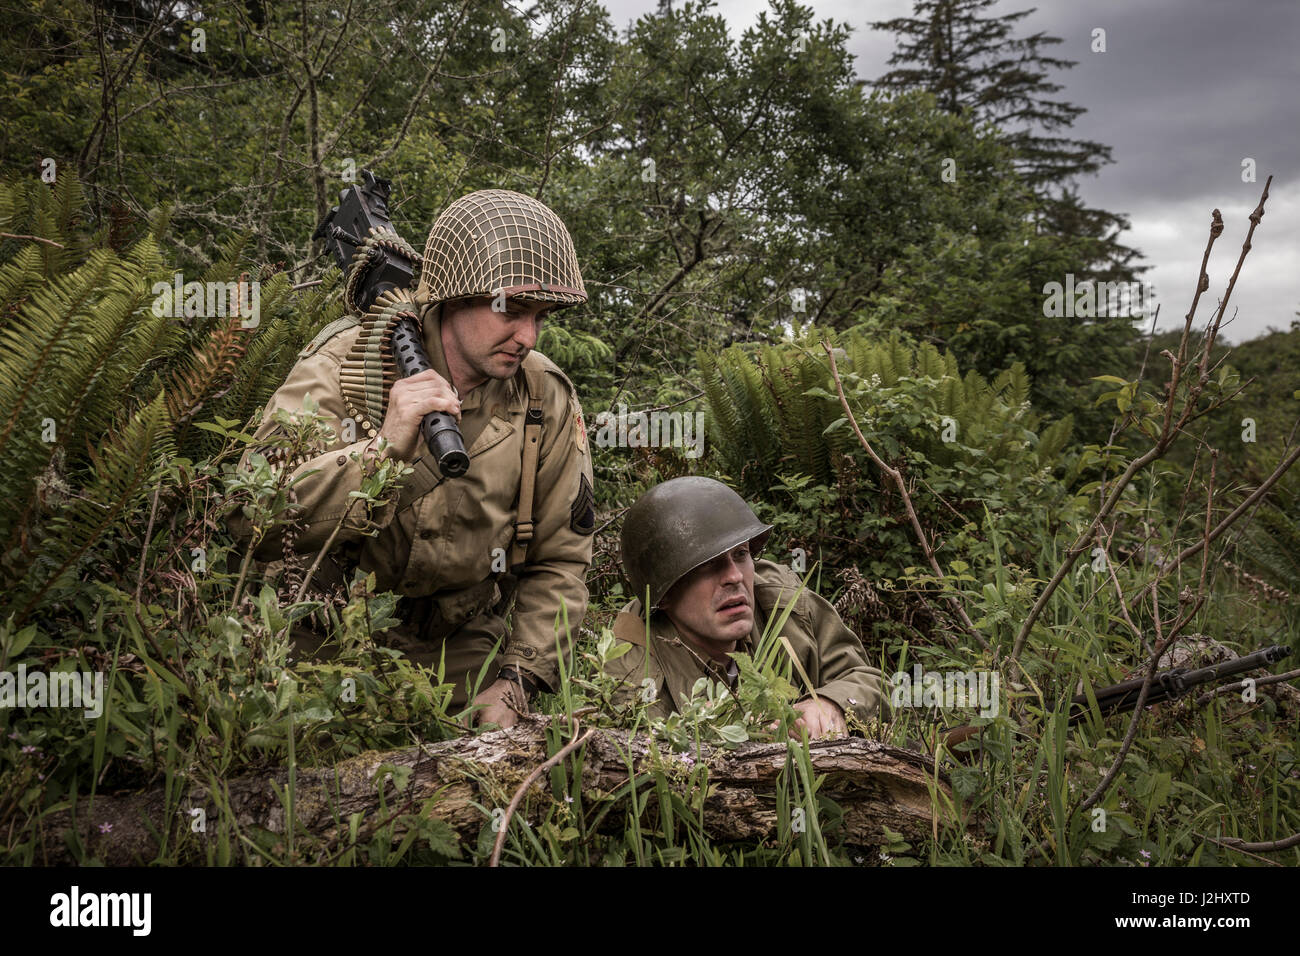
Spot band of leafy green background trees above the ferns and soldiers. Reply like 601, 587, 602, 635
0, 0, 1134, 442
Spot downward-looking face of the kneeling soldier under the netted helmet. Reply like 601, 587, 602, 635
442, 298, 554, 388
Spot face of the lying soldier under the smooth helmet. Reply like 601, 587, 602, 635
659, 544, 754, 661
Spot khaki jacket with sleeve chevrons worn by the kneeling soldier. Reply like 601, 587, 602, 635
230, 299, 594, 688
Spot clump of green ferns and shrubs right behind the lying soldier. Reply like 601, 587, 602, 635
698, 325, 1086, 636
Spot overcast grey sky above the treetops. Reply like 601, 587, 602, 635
602, 0, 1300, 342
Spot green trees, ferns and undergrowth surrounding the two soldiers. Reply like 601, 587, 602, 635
0, 0, 1300, 865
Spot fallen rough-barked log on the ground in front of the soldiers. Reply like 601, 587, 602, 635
35, 715, 953, 866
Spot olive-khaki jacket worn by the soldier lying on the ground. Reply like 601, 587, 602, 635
606, 561, 884, 719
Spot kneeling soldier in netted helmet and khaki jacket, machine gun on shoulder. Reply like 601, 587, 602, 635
231, 190, 595, 726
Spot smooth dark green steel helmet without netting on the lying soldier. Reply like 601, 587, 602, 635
620, 477, 772, 609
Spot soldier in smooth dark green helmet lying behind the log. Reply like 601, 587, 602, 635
605, 477, 884, 739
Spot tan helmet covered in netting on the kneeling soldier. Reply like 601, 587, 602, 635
416, 189, 586, 307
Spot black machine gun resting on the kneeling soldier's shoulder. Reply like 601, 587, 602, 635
312, 169, 469, 477
